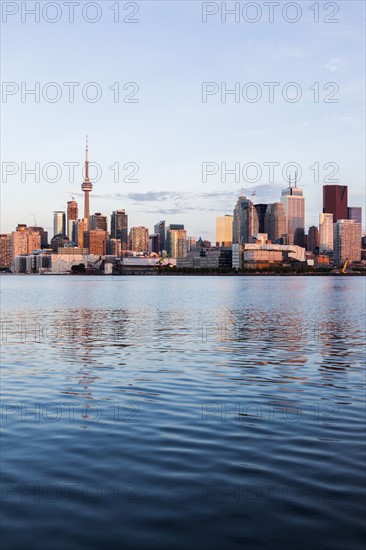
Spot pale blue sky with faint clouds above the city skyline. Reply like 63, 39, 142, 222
1, 0, 366, 240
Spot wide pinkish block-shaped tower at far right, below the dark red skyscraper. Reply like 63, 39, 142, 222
333, 220, 361, 263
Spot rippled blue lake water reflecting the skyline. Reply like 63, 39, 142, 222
1, 275, 365, 550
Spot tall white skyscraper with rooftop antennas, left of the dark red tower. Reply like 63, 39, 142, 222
281, 179, 305, 246
